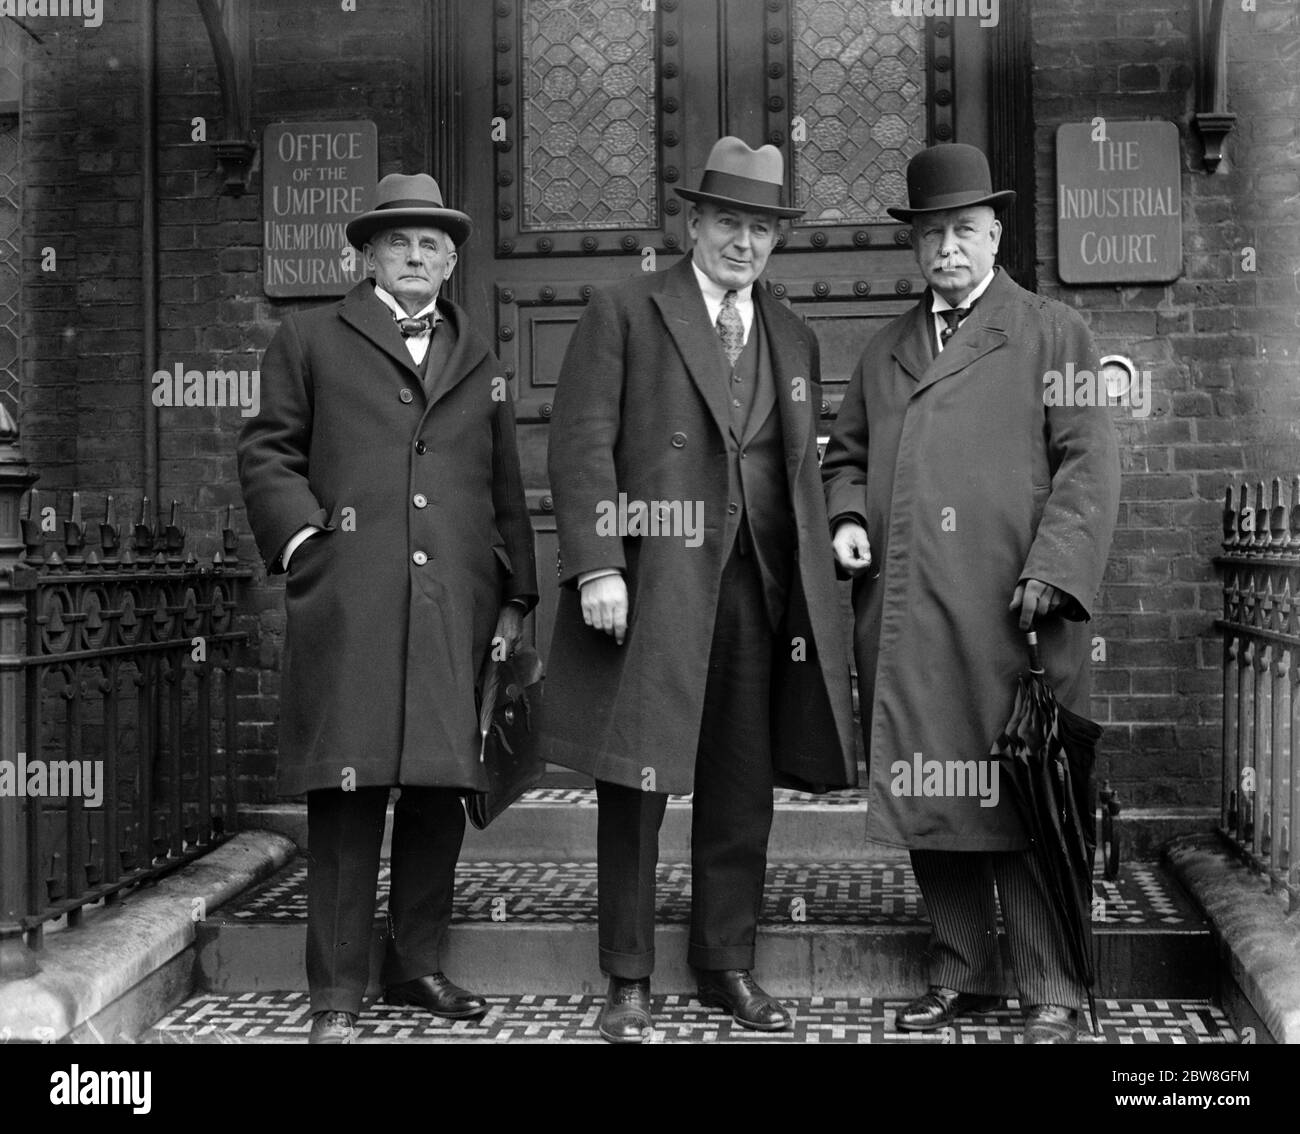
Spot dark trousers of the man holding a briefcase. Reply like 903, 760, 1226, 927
307, 788, 465, 1013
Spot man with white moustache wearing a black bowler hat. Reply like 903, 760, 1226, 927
822, 144, 1119, 1043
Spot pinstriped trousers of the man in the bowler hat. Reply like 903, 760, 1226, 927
911, 851, 1087, 1008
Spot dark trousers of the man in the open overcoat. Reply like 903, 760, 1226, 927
595, 543, 774, 979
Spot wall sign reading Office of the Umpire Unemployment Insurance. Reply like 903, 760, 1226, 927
261, 122, 380, 299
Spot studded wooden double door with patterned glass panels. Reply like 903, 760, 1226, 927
433, 0, 1034, 653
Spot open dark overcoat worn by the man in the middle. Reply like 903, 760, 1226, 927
541, 257, 855, 793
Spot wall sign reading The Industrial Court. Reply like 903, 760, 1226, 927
1057, 118, 1183, 284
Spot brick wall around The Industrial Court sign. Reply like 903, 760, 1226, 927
1032, 0, 1300, 806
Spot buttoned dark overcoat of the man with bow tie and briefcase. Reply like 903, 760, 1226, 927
239, 280, 537, 795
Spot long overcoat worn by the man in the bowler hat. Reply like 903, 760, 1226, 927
822, 270, 1119, 851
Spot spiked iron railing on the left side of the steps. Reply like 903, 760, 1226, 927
0, 415, 251, 978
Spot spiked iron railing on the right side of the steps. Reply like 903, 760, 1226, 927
1214, 476, 1300, 913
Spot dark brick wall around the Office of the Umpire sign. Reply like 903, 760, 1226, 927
21, 0, 429, 800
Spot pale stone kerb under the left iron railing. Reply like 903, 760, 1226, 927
0, 831, 295, 1042
